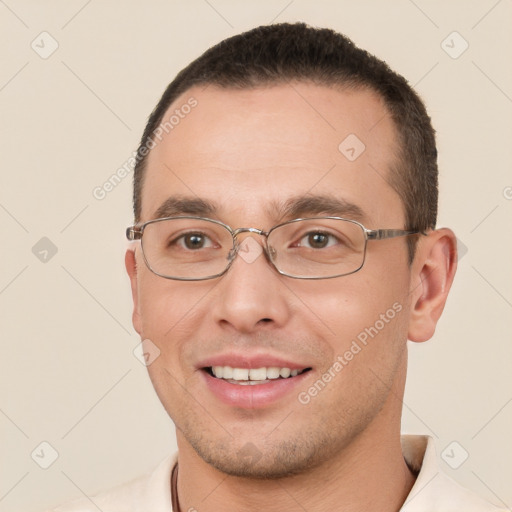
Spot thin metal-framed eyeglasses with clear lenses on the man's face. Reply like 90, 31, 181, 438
126, 216, 419, 281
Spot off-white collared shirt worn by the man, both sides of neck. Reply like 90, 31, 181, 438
48, 435, 505, 512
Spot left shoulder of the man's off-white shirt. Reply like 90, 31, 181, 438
46, 455, 176, 512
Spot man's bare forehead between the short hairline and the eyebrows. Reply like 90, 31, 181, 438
142, 83, 403, 223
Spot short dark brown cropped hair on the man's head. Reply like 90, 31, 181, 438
133, 23, 438, 260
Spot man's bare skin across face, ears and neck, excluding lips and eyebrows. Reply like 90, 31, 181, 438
126, 83, 456, 512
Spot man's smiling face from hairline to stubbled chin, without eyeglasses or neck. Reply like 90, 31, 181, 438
127, 84, 416, 477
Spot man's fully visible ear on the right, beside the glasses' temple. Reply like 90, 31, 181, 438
408, 228, 457, 342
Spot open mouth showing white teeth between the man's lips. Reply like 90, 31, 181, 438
203, 366, 311, 386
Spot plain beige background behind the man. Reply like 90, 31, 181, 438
0, 0, 512, 512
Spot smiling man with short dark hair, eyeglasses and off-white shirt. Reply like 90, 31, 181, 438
50, 24, 506, 512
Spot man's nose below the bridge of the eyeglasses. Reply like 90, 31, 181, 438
213, 234, 290, 334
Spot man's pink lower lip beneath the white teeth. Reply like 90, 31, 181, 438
201, 370, 311, 409
